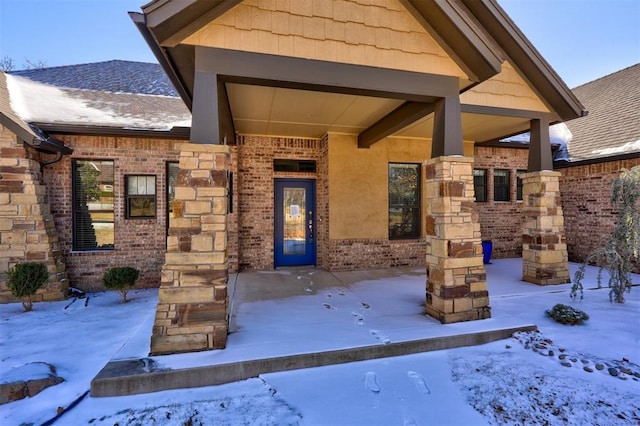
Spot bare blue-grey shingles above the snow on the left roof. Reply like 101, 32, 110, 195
10, 60, 178, 97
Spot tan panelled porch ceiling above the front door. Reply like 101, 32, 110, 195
226, 83, 530, 142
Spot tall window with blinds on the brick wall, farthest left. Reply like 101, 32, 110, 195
71, 160, 114, 251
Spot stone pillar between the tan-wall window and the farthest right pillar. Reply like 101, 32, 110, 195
425, 156, 491, 324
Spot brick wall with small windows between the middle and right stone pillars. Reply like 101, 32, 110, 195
473, 146, 529, 259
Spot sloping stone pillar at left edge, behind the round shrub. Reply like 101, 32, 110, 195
0, 126, 69, 303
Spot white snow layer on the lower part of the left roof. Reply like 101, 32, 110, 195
7, 73, 191, 130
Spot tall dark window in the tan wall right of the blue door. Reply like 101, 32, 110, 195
389, 164, 420, 240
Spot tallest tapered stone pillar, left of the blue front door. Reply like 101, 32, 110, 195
151, 144, 230, 355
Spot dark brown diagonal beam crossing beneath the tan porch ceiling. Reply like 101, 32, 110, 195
358, 102, 435, 148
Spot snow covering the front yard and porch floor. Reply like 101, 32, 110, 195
0, 259, 640, 426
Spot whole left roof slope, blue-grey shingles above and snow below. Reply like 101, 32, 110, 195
7, 60, 191, 131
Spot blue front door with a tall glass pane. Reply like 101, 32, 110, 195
274, 179, 316, 267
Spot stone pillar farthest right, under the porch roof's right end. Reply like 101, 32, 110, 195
522, 171, 571, 285
